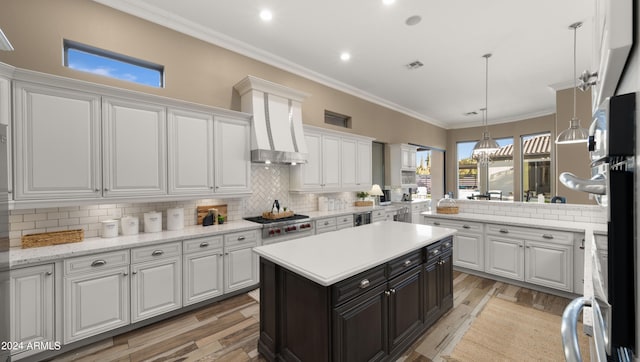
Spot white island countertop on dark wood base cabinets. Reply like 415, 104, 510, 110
253, 221, 456, 286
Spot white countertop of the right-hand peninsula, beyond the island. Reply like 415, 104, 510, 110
422, 211, 607, 233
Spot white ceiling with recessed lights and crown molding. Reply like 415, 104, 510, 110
95, 0, 594, 128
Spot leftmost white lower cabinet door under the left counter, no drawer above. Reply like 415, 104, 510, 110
7, 264, 56, 354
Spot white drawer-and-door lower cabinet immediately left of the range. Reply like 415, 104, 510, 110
224, 230, 259, 293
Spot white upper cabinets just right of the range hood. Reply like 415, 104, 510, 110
290, 126, 373, 192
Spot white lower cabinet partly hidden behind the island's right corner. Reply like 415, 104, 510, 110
424, 217, 485, 271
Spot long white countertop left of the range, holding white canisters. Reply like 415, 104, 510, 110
9, 220, 262, 268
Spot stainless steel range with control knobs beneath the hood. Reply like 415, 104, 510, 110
244, 214, 313, 244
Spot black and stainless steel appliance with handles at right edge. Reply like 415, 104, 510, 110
560, 93, 640, 361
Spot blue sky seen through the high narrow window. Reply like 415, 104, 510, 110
67, 48, 162, 88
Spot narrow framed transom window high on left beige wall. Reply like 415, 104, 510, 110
63, 39, 164, 88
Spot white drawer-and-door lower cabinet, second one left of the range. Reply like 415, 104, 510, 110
182, 236, 224, 306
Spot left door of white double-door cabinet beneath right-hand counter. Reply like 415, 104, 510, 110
485, 235, 524, 280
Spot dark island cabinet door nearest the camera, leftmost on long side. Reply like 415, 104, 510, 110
333, 283, 389, 362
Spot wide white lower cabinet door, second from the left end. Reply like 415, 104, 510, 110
64, 265, 130, 343
